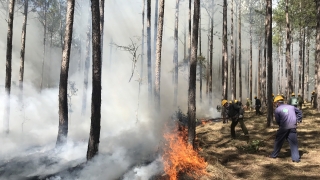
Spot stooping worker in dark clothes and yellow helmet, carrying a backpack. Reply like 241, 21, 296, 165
221, 99, 249, 139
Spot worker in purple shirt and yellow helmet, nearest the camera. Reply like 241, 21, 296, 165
269, 96, 302, 162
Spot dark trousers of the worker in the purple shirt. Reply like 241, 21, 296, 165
271, 128, 300, 161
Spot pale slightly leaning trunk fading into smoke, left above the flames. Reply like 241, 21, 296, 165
154, 0, 164, 109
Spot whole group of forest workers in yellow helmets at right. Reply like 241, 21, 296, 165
221, 93, 303, 162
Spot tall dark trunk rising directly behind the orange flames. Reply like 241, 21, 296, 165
188, 0, 200, 148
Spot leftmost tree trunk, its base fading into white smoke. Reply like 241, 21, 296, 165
3, 0, 15, 134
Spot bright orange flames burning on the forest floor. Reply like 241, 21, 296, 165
162, 128, 207, 180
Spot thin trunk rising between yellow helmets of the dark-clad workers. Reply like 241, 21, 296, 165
230, 0, 236, 100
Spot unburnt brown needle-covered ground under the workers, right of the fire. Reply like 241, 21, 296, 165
196, 104, 320, 180
